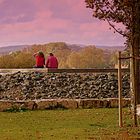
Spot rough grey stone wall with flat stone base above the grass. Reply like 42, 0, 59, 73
0, 72, 130, 111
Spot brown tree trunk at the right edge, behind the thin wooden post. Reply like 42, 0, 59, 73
130, 0, 140, 126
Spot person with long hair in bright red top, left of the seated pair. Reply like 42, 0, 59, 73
34, 51, 45, 68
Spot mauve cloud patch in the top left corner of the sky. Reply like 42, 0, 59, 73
0, 0, 37, 24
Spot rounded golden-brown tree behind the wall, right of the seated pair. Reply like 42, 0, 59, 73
67, 46, 107, 68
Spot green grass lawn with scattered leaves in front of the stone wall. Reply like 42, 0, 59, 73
0, 108, 140, 140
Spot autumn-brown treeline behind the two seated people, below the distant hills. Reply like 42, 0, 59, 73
0, 42, 120, 68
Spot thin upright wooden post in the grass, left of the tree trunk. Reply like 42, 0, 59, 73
118, 52, 123, 127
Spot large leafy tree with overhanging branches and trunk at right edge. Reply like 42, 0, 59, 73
85, 0, 140, 126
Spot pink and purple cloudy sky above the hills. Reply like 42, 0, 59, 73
0, 0, 125, 47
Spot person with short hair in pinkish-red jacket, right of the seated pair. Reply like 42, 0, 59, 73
46, 53, 58, 68
